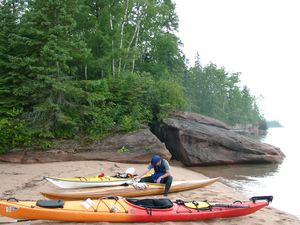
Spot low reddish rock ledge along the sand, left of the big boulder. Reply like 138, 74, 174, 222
0, 129, 171, 163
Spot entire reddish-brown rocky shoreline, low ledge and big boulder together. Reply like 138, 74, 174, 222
0, 112, 285, 166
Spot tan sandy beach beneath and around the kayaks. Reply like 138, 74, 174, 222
0, 161, 300, 225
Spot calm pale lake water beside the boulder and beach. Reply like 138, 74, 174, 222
192, 127, 300, 218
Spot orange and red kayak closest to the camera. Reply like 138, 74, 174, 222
0, 196, 273, 222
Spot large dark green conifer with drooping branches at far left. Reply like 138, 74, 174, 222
7, 0, 89, 137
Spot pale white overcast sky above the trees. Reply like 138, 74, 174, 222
174, 0, 300, 125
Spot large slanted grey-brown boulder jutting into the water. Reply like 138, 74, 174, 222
153, 112, 285, 166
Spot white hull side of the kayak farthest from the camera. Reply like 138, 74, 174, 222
45, 177, 132, 188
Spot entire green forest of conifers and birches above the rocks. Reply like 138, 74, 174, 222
0, 0, 265, 153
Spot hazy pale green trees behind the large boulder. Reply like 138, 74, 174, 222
183, 60, 263, 125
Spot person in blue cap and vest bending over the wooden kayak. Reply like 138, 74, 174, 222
137, 155, 173, 197
